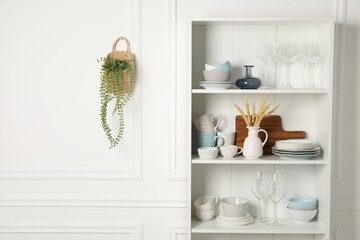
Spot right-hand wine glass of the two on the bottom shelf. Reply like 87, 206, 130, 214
268, 172, 285, 226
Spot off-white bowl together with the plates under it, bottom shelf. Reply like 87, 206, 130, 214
216, 197, 253, 226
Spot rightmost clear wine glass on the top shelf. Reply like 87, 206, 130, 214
301, 42, 326, 88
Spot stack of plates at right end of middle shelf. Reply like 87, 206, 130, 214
272, 140, 320, 160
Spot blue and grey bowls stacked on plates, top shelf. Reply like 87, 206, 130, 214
200, 61, 234, 89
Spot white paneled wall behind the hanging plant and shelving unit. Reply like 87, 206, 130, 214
0, 0, 360, 240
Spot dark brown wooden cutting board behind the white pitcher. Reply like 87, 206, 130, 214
235, 115, 306, 155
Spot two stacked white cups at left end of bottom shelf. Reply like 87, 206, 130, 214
194, 196, 219, 221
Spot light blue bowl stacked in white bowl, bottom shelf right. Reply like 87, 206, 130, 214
287, 197, 318, 223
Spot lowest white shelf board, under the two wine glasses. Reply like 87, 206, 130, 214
191, 218, 326, 234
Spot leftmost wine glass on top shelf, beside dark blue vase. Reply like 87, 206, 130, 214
256, 42, 276, 88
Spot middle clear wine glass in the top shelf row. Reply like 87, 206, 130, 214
277, 42, 300, 88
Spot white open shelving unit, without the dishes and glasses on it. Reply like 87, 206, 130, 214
187, 18, 334, 240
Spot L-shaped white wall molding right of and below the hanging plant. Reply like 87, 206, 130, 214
0, 0, 143, 181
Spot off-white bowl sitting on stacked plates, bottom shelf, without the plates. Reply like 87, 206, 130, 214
220, 197, 249, 218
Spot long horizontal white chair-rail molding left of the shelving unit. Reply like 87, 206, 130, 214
0, 195, 187, 208
